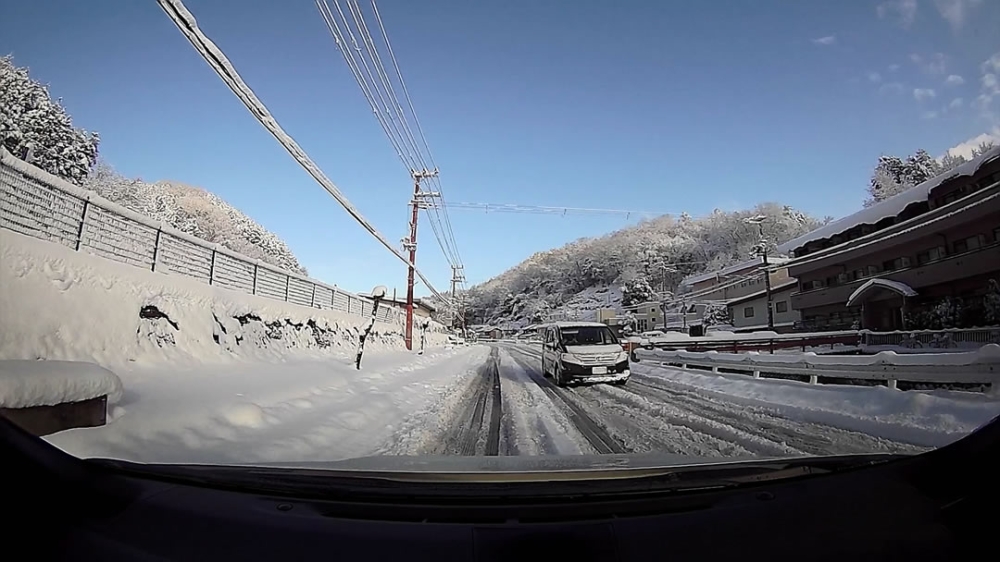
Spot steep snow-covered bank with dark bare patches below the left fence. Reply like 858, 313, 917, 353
0, 230, 446, 368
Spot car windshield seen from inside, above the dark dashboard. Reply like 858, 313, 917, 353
0, 0, 1000, 484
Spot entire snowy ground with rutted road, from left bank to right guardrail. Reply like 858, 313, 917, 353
46, 344, 1000, 464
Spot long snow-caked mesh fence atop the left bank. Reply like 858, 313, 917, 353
0, 147, 402, 323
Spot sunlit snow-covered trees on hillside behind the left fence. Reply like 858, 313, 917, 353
84, 162, 307, 274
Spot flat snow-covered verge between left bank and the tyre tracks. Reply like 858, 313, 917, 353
45, 346, 489, 464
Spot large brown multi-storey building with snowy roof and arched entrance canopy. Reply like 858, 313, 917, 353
778, 147, 1000, 330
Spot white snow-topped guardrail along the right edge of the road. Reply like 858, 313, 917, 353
634, 344, 1000, 388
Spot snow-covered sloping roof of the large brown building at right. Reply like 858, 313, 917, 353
778, 146, 1000, 253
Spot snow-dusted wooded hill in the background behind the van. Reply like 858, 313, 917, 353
464, 203, 823, 325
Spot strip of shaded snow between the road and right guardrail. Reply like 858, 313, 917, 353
632, 364, 1000, 447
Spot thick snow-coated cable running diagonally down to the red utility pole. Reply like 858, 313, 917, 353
157, 0, 450, 303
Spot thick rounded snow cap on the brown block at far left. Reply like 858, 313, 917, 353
0, 360, 122, 408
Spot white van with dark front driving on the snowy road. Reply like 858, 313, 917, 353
542, 322, 629, 386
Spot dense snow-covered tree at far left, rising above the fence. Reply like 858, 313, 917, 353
0, 55, 100, 185
